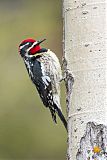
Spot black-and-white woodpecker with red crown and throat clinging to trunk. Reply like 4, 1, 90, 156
19, 38, 67, 130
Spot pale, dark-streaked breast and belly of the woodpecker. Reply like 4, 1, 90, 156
37, 50, 62, 109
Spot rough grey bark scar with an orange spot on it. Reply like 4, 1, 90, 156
76, 122, 107, 160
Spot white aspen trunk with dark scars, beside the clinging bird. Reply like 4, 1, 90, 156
63, 0, 107, 160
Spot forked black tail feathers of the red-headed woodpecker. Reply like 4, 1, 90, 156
49, 104, 67, 130
